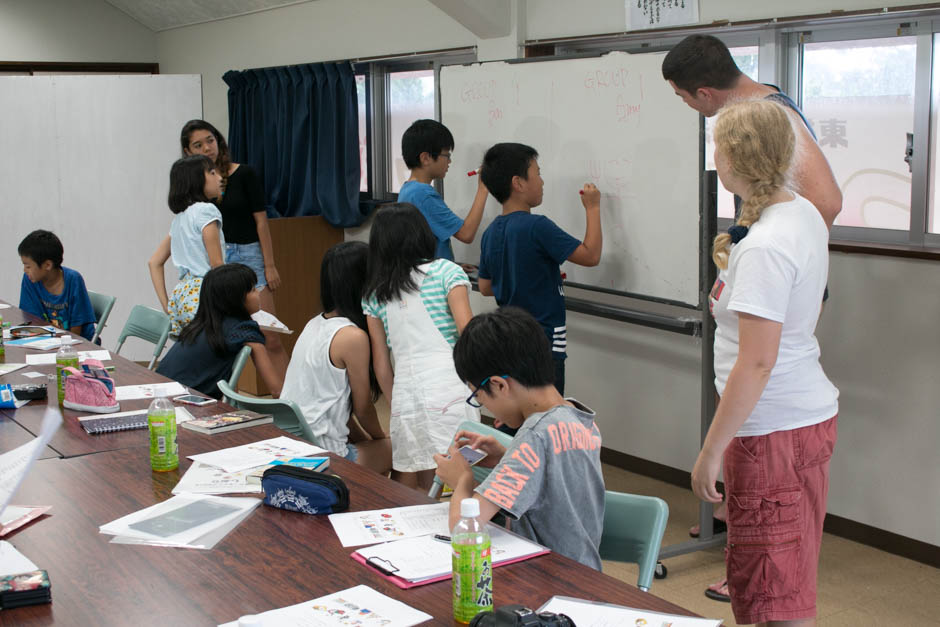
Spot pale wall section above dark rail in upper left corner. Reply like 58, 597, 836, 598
0, 0, 157, 63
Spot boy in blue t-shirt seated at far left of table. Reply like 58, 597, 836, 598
16, 230, 95, 340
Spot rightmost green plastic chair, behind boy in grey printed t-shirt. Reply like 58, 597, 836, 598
600, 490, 669, 592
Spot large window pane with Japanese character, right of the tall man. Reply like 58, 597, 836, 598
802, 37, 916, 231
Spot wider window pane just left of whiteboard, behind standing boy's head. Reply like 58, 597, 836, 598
388, 70, 434, 194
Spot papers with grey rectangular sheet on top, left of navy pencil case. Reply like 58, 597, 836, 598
99, 494, 261, 549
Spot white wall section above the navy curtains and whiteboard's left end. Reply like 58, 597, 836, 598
157, 0, 476, 137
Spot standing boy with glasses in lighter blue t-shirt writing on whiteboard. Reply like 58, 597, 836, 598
398, 120, 486, 261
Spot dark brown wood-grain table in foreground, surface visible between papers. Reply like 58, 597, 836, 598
0, 444, 689, 626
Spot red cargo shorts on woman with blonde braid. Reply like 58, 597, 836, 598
724, 417, 838, 625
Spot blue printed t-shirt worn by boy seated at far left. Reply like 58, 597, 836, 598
20, 266, 95, 340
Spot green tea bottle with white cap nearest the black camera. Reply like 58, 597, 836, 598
450, 499, 493, 623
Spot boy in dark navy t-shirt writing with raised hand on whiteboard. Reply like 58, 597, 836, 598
479, 143, 602, 394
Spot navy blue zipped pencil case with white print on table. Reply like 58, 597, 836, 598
261, 466, 349, 514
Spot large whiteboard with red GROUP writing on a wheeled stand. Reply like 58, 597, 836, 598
440, 52, 702, 307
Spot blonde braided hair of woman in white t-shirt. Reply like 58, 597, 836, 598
712, 100, 796, 269
